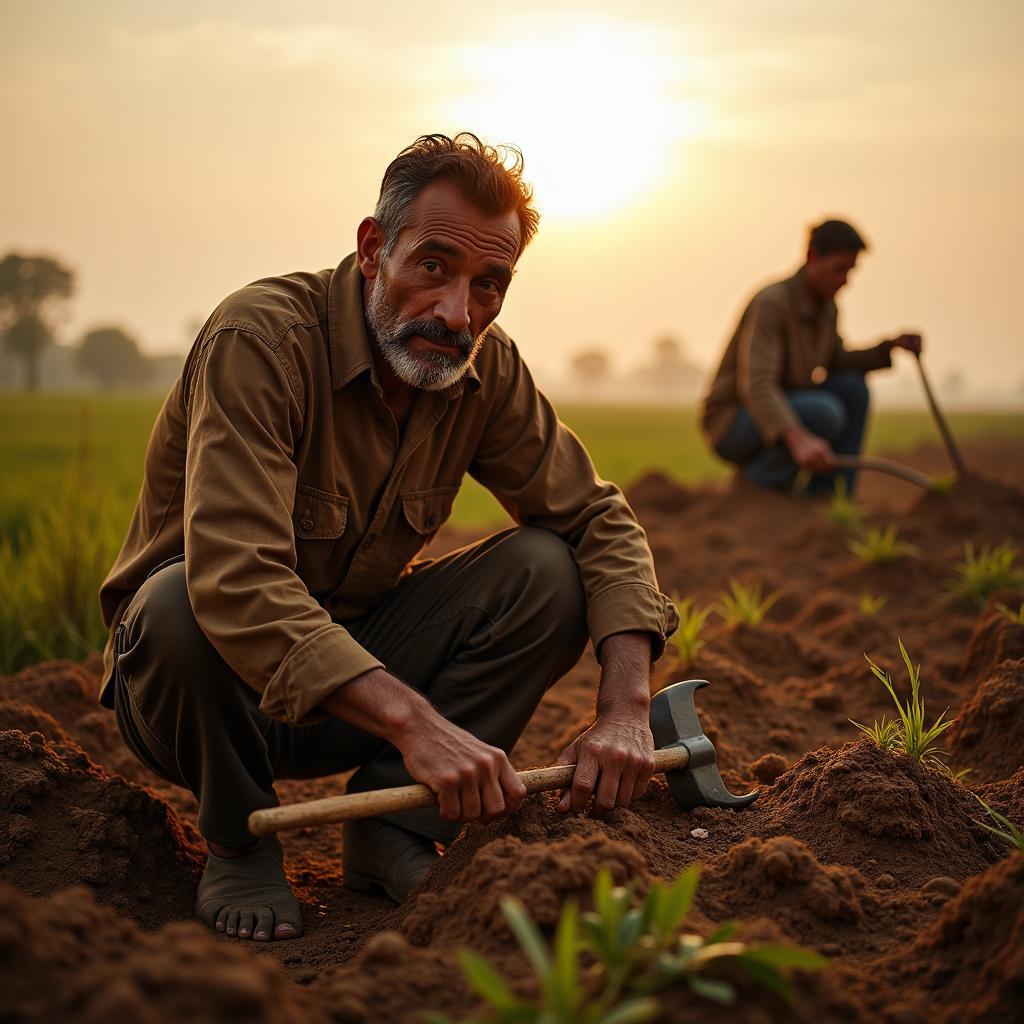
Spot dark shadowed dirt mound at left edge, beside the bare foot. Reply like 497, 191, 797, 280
0, 730, 202, 927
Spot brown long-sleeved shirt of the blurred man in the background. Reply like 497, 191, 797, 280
700, 268, 892, 444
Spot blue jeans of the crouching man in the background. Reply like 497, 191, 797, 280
715, 370, 868, 495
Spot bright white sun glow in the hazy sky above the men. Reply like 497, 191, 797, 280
444, 19, 705, 220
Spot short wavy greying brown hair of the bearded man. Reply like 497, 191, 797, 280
374, 132, 541, 259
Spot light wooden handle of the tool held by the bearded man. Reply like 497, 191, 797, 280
249, 745, 690, 836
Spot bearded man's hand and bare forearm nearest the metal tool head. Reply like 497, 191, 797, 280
556, 633, 654, 817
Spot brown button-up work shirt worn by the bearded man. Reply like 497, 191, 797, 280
100, 256, 678, 723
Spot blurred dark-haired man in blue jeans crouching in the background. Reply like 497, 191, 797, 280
701, 220, 921, 494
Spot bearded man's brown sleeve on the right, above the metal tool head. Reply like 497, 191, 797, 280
470, 342, 679, 657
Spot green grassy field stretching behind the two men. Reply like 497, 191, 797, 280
0, 394, 1024, 672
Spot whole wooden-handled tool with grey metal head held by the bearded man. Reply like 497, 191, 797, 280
249, 679, 758, 836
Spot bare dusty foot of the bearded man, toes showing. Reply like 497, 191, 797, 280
196, 839, 302, 942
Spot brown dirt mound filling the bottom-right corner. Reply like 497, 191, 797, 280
880, 853, 1024, 1024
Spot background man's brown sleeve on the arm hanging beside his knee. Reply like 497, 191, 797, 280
736, 295, 800, 444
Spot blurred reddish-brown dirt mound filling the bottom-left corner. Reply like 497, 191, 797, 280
0, 885, 327, 1024
